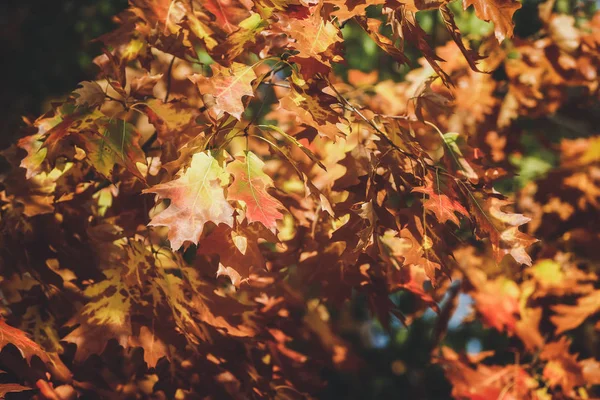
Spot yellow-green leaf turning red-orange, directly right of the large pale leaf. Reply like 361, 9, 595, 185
227, 151, 284, 232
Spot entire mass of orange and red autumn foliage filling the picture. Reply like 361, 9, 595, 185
0, 0, 600, 399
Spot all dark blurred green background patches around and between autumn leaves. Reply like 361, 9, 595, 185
0, 0, 600, 399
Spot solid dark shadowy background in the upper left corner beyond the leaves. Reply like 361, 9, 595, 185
0, 0, 127, 148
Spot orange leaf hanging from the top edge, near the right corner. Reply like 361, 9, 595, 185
463, 0, 521, 43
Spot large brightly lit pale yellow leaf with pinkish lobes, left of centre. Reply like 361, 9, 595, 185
143, 152, 233, 249
